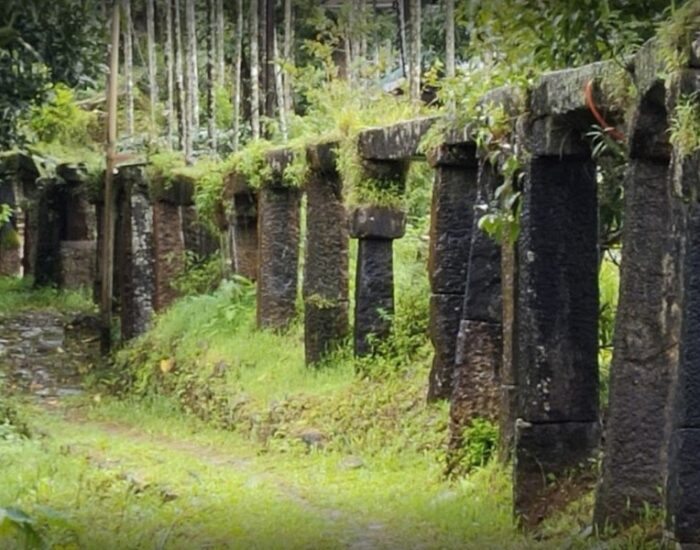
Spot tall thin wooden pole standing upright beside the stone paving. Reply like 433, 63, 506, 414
100, 2, 120, 354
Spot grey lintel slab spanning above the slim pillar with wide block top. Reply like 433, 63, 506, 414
357, 117, 438, 160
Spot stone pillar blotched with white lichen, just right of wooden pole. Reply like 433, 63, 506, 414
117, 165, 156, 340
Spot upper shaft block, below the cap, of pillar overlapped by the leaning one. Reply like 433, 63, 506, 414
428, 166, 478, 295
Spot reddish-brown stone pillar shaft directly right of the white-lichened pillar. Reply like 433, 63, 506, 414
153, 201, 185, 311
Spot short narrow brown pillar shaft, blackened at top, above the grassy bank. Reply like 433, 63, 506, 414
232, 191, 258, 281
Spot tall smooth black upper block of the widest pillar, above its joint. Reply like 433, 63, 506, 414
517, 157, 598, 422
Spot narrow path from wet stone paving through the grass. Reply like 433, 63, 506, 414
0, 311, 398, 550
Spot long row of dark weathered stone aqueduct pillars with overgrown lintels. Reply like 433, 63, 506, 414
0, 46, 700, 544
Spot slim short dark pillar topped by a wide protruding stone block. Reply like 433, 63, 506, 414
350, 206, 406, 356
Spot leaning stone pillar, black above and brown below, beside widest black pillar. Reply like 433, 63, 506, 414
450, 161, 503, 470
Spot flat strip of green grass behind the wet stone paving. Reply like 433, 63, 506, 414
0, 276, 95, 315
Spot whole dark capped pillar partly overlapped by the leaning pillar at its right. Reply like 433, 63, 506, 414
428, 144, 478, 401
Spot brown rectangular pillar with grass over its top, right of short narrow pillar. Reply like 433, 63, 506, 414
257, 149, 301, 329
